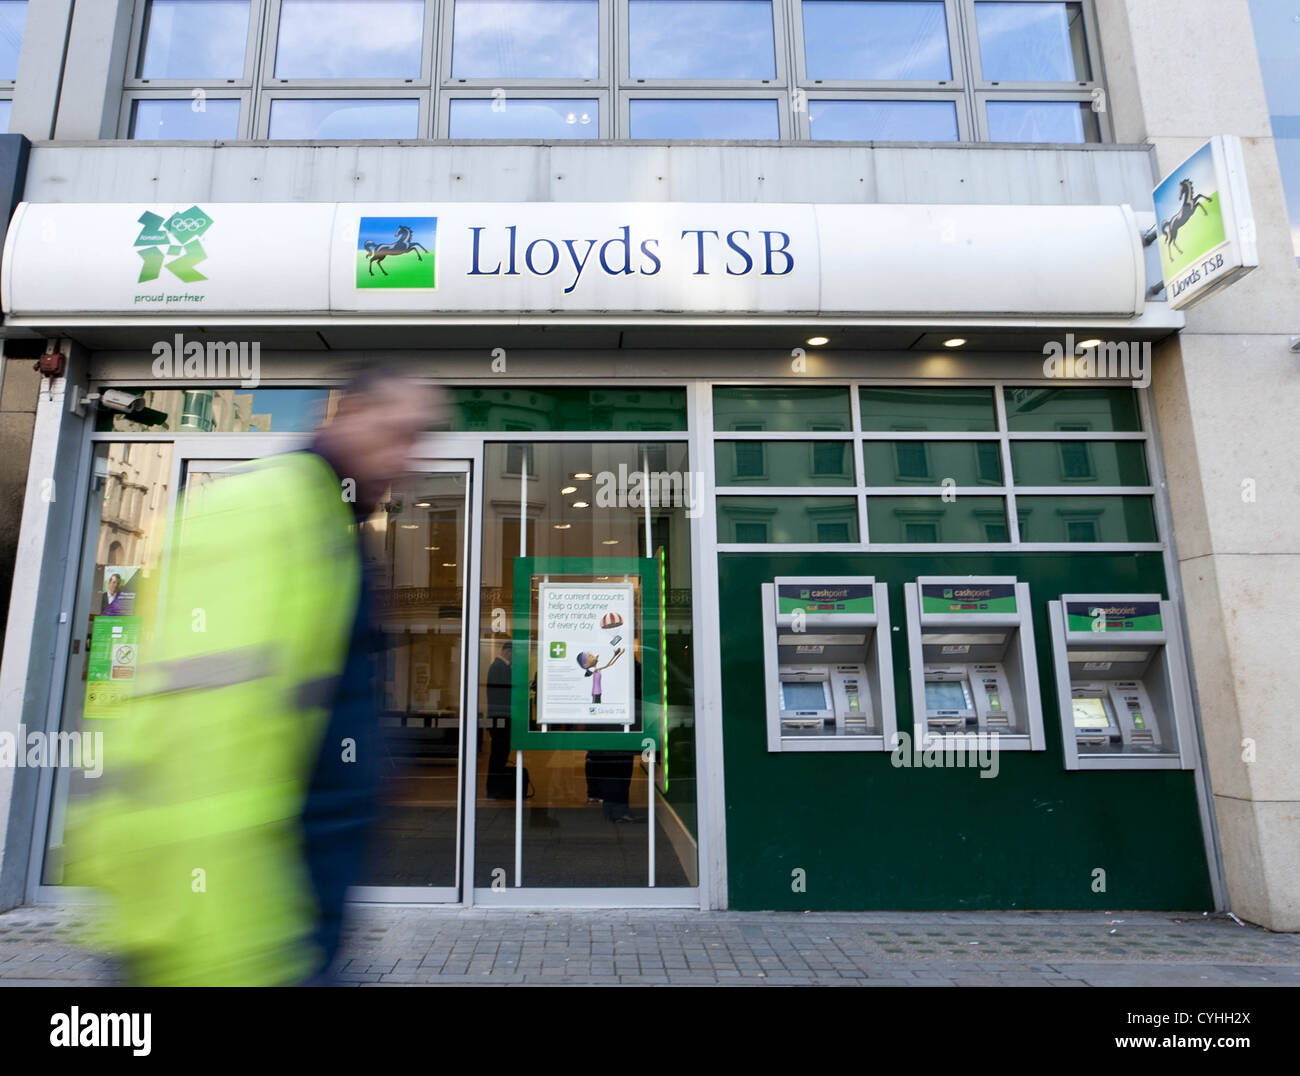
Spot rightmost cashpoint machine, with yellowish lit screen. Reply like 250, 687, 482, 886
1048, 594, 1195, 769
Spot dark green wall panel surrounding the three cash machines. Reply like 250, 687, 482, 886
719, 552, 1213, 911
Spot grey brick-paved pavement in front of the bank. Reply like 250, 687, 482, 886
0, 904, 1300, 986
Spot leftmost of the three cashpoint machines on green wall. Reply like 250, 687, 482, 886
762, 576, 897, 751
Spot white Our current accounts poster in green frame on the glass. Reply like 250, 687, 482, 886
537, 582, 636, 726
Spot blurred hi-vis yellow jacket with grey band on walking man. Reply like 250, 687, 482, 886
65, 452, 361, 985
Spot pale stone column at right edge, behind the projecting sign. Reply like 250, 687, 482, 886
1097, 0, 1300, 930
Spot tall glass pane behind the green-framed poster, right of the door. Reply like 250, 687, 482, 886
478, 442, 699, 888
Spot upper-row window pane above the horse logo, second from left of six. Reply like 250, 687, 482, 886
276, 0, 424, 78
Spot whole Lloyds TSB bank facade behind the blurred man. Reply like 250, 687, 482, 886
0, 0, 1300, 929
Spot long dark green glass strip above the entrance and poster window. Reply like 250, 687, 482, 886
449, 386, 686, 431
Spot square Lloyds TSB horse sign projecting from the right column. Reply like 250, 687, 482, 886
1152, 135, 1260, 309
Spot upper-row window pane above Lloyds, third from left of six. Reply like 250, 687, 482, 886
451, 0, 601, 78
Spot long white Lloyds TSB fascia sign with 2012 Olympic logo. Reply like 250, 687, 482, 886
0, 201, 1145, 321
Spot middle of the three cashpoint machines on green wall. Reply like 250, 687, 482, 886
904, 576, 1045, 751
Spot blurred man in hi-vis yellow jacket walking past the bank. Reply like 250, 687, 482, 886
69, 370, 441, 985
